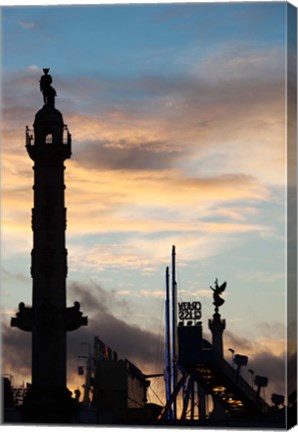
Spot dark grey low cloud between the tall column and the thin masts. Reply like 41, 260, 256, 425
68, 282, 160, 369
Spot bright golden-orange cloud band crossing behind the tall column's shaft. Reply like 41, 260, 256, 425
3, 150, 272, 268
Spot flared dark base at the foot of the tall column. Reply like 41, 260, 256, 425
22, 386, 79, 424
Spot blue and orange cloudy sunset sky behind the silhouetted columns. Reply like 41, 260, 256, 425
1, 2, 296, 401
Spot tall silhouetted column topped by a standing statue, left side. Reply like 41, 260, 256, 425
11, 69, 87, 423
